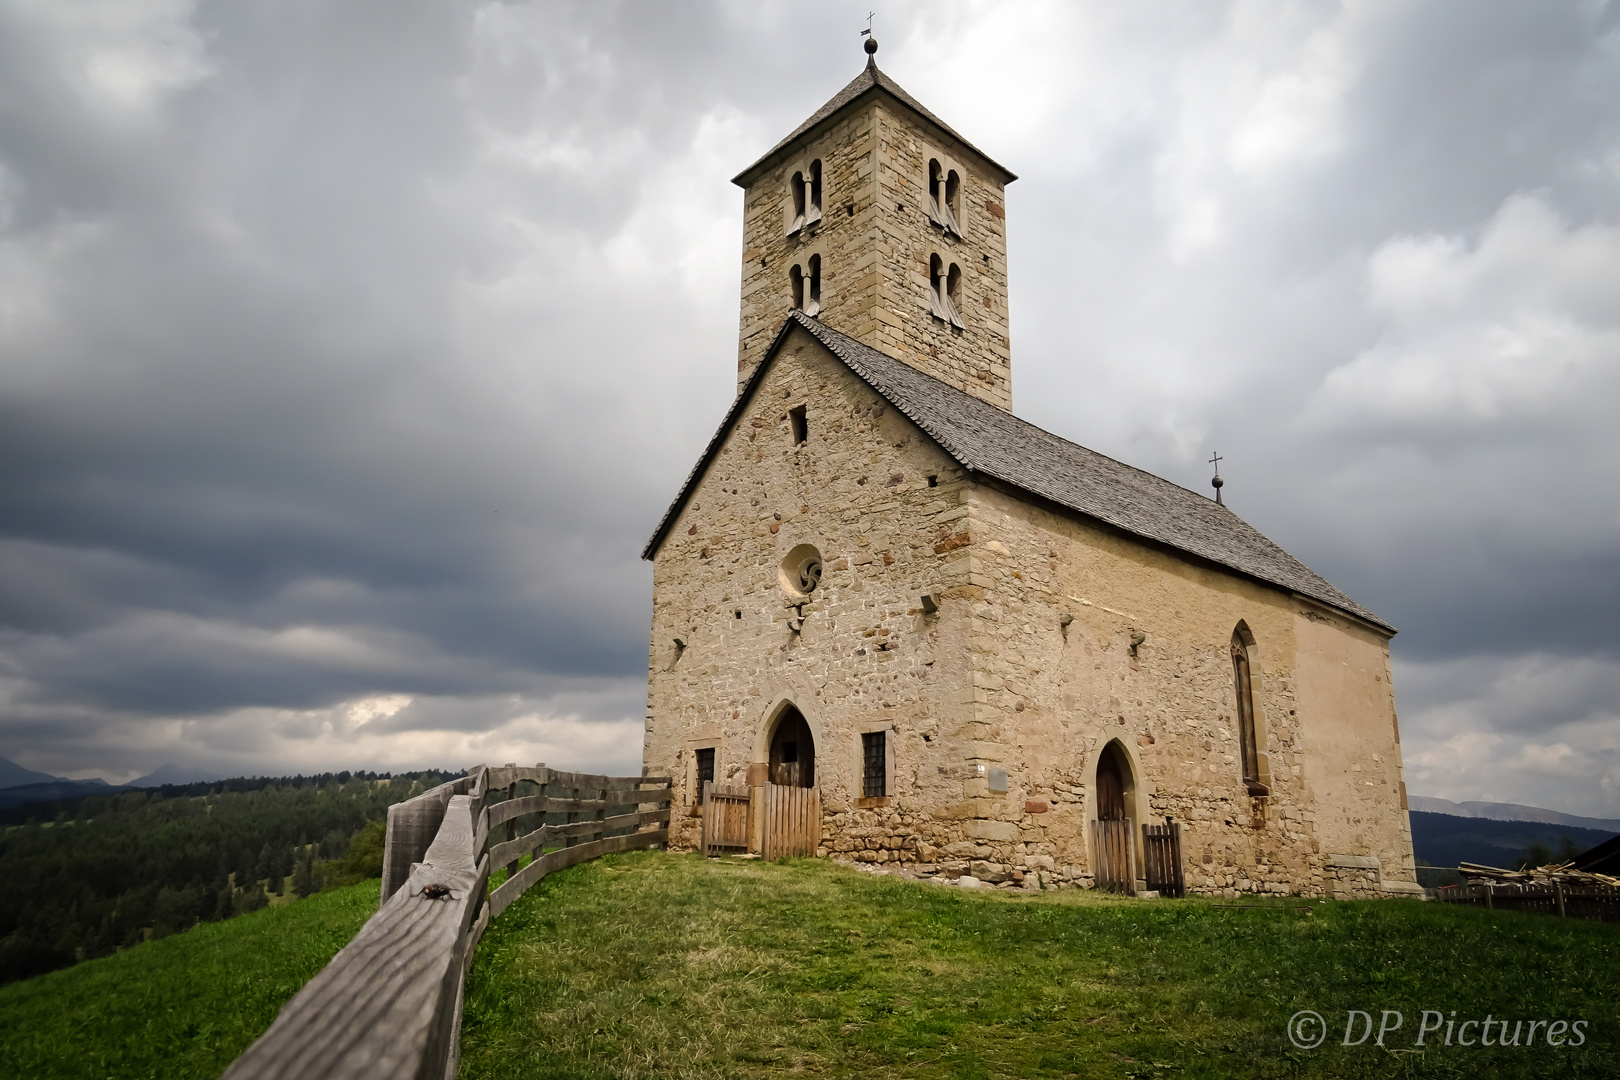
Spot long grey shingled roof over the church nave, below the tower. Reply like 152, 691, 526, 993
642, 311, 1395, 633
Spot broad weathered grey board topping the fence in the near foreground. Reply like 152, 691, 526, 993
225, 795, 489, 1080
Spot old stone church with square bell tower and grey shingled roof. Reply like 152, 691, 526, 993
643, 39, 1421, 897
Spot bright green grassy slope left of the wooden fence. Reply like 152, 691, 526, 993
0, 881, 377, 1080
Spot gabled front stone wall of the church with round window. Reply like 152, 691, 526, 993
645, 329, 967, 845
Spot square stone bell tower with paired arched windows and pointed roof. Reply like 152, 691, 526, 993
732, 37, 1017, 411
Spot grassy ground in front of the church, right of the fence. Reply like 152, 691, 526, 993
462, 853, 1620, 1078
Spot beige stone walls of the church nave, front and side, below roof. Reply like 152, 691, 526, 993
646, 330, 1411, 895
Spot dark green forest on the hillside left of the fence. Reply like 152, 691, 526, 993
0, 771, 460, 983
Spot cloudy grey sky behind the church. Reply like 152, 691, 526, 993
0, 0, 1620, 816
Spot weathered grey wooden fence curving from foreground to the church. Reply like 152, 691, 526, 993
225, 764, 671, 1080
